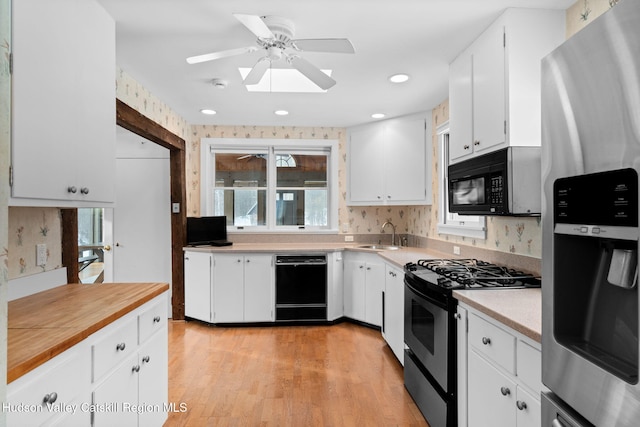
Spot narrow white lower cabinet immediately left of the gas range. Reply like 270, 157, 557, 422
382, 263, 404, 366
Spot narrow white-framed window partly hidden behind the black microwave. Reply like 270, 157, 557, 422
437, 122, 487, 240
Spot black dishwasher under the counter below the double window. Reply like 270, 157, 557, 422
276, 255, 327, 321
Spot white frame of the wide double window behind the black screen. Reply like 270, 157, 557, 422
200, 138, 340, 234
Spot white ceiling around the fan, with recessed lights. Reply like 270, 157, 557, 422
98, 0, 575, 127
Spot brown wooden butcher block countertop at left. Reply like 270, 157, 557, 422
7, 283, 169, 383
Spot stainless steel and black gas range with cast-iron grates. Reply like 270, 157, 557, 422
404, 259, 540, 427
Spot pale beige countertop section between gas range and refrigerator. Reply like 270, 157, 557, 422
453, 289, 542, 342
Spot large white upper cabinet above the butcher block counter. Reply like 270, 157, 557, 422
9, 0, 116, 207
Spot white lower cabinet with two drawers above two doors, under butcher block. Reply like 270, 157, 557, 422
91, 294, 169, 427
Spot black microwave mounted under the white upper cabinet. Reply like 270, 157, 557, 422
447, 147, 542, 216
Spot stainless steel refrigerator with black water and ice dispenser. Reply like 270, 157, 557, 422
542, 0, 640, 427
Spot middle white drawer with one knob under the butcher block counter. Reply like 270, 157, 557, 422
91, 317, 138, 382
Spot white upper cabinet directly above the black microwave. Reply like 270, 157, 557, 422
449, 9, 565, 163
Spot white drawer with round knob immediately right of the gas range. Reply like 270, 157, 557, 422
469, 313, 516, 374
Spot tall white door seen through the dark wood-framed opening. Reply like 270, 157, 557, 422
103, 127, 171, 313
